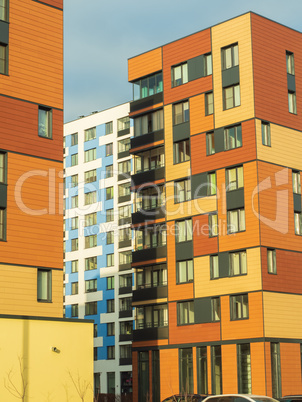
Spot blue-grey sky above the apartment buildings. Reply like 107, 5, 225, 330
64, 0, 302, 122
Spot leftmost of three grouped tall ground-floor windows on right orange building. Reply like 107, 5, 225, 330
179, 348, 194, 395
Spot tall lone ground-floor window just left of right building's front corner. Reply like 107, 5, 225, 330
237, 343, 252, 394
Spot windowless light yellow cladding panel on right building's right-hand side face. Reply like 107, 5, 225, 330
263, 292, 302, 339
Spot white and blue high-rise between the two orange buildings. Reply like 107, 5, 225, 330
64, 103, 133, 395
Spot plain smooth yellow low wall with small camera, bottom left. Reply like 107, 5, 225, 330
0, 318, 93, 402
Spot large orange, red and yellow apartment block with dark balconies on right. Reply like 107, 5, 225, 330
128, 12, 302, 402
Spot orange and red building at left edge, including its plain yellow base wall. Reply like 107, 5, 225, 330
0, 0, 93, 402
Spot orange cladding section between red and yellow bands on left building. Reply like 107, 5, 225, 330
0, 153, 63, 268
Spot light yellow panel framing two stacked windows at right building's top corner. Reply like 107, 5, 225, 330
211, 13, 254, 128
